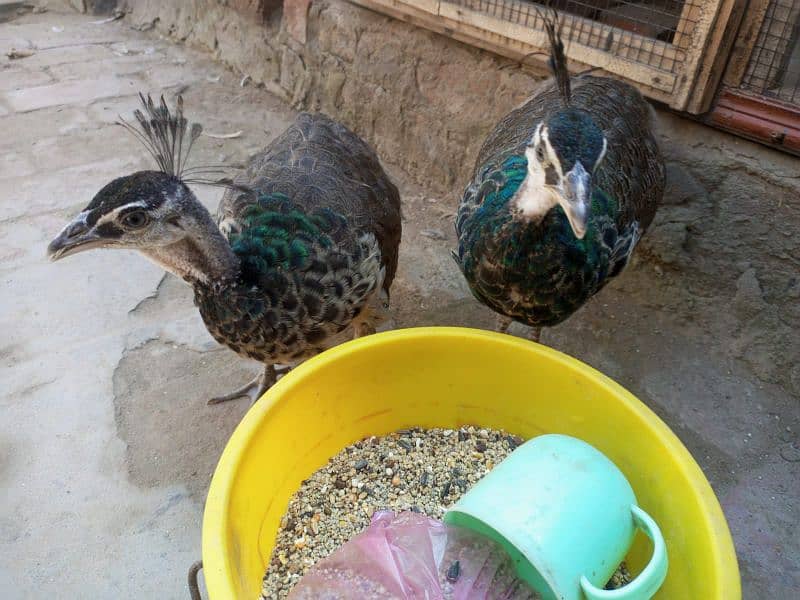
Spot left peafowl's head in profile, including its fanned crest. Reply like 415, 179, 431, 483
47, 96, 236, 283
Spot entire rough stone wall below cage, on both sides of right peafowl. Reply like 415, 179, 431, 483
119, 0, 800, 404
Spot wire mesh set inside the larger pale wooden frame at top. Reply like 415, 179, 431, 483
448, 0, 702, 73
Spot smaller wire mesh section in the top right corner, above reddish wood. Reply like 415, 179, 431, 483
740, 0, 800, 105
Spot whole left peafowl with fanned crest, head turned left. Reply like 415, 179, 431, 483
48, 97, 401, 403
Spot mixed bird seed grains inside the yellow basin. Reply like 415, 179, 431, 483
261, 427, 630, 600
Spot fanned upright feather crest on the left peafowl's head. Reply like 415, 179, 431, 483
117, 93, 203, 177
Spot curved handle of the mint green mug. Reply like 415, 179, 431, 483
581, 504, 669, 600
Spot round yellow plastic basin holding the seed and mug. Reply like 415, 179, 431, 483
203, 327, 741, 600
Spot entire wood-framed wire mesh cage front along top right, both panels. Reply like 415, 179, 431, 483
349, 0, 800, 155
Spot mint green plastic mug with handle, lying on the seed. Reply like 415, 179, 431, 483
444, 435, 667, 600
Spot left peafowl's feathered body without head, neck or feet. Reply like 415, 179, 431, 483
195, 114, 400, 364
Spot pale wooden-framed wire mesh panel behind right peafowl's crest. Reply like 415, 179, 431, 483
350, 0, 764, 115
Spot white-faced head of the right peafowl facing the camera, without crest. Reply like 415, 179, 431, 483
519, 107, 608, 239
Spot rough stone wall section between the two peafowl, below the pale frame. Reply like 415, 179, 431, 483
122, 0, 536, 191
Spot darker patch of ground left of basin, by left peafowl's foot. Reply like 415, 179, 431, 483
114, 340, 253, 502
